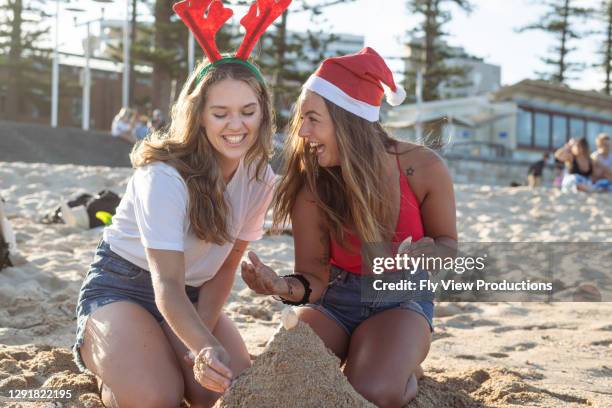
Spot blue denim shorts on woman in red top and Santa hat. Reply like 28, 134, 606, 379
307, 265, 434, 336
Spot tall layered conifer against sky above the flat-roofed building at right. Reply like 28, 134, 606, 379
518, 0, 592, 83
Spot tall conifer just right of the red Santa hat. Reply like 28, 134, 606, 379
404, 0, 472, 101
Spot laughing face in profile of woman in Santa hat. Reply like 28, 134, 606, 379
298, 91, 340, 167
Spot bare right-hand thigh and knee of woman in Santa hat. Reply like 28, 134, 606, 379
344, 309, 431, 408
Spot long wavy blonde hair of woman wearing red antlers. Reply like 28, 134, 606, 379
130, 62, 274, 245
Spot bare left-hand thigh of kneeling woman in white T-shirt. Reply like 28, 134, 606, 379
81, 302, 183, 408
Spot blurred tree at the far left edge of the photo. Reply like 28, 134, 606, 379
0, 0, 51, 120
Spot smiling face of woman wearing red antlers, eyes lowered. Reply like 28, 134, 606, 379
200, 78, 262, 174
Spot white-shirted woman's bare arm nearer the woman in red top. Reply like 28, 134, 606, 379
198, 239, 249, 331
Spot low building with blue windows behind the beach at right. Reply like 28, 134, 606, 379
385, 80, 612, 185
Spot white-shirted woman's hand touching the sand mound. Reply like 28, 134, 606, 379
193, 346, 233, 393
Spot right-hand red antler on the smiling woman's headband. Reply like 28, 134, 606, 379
236, 0, 291, 60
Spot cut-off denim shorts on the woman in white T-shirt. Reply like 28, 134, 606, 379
72, 240, 200, 371
